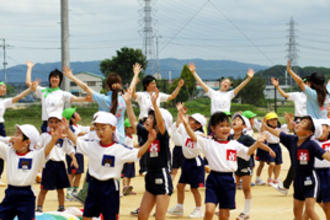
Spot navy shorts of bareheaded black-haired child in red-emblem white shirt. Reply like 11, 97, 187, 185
205, 171, 236, 209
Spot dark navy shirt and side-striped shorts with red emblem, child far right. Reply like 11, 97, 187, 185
280, 132, 326, 201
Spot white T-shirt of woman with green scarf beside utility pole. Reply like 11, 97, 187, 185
35, 86, 72, 121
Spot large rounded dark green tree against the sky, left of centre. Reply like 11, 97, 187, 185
100, 47, 147, 85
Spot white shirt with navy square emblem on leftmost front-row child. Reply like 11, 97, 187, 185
0, 143, 46, 186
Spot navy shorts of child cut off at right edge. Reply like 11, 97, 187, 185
315, 168, 330, 203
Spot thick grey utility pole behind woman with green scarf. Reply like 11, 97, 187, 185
61, 0, 70, 91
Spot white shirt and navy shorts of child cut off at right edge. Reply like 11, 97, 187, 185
314, 140, 330, 203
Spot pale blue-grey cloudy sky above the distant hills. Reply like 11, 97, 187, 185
0, 0, 330, 71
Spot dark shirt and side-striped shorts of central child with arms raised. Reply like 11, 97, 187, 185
137, 124, 173, 195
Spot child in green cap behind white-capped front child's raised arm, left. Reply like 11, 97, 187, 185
62, 108, 89, 200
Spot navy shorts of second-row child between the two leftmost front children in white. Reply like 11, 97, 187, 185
41, 160, 70, 190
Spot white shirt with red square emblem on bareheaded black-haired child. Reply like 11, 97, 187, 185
194, 136, 250, 172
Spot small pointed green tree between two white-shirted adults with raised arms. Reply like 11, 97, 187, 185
171, 65, 196, 102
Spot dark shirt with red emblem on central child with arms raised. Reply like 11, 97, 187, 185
137, 124, 171, 172
